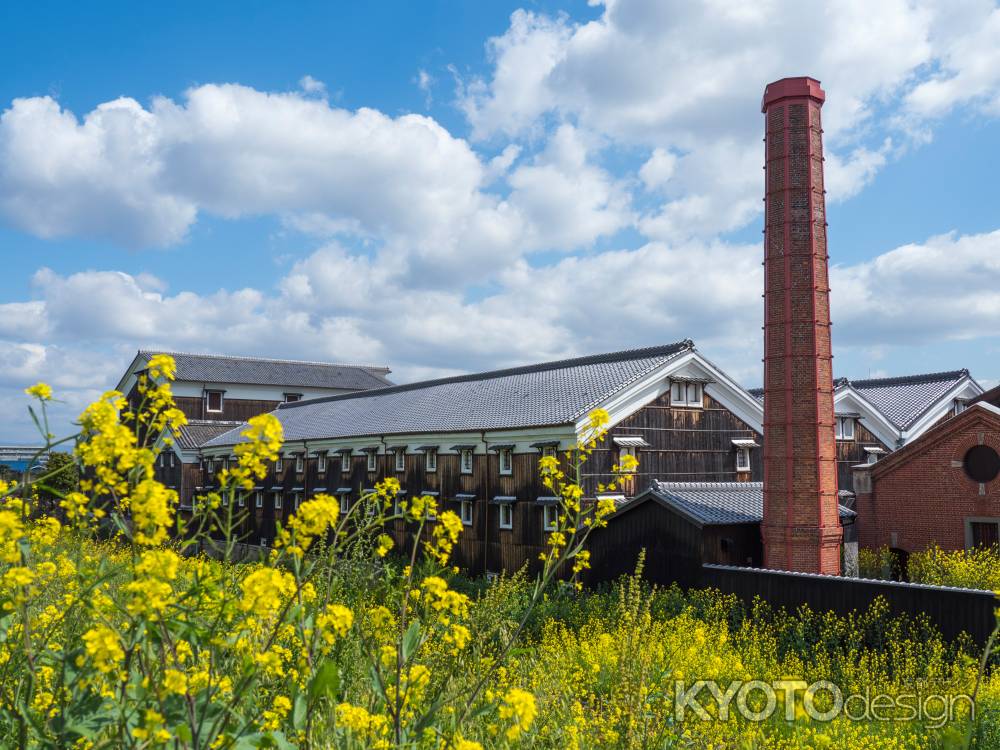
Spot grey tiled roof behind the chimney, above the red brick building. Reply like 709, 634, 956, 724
749, 370, 969, 430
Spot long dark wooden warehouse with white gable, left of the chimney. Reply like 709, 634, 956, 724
202, 341, 762, 573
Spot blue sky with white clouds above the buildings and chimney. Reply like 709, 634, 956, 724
0, 0, 1000, 441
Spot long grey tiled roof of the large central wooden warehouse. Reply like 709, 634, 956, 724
209, 341, 694, 445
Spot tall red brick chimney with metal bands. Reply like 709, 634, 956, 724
761, 78, 843, 575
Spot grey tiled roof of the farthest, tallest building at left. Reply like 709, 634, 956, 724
139, 350, 391, 390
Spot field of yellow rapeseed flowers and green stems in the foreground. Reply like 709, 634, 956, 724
0, 357, 1000, 750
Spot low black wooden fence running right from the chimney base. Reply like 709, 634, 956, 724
699, 565, 997, 644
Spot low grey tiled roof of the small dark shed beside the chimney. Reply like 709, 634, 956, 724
636, 481, 855, 526
